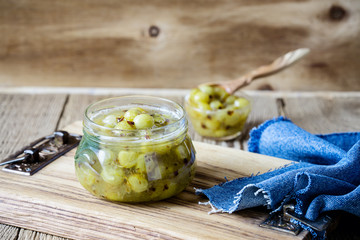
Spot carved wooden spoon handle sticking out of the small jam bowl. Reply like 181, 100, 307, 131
201, 48, 310, 94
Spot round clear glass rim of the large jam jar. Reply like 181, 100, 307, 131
83, 95, 187, 142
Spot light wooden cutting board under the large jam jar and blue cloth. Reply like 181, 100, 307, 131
0, 122, 307, 239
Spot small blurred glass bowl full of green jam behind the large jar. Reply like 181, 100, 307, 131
185, 85, 251, 140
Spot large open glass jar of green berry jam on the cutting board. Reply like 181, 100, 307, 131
75, 96, 196, 202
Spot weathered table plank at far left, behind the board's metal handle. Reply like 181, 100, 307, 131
0, 94, 66, 160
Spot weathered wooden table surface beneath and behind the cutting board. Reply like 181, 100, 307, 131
0, 88, 360, 239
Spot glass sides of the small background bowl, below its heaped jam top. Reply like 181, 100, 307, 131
185, 93, 251, 140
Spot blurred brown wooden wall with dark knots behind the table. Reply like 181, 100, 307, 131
0, 0, 360, 91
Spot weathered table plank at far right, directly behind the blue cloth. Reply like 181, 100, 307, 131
284, 95, 360, 134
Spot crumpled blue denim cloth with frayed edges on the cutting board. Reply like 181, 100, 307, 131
196, 117, 360, 238
